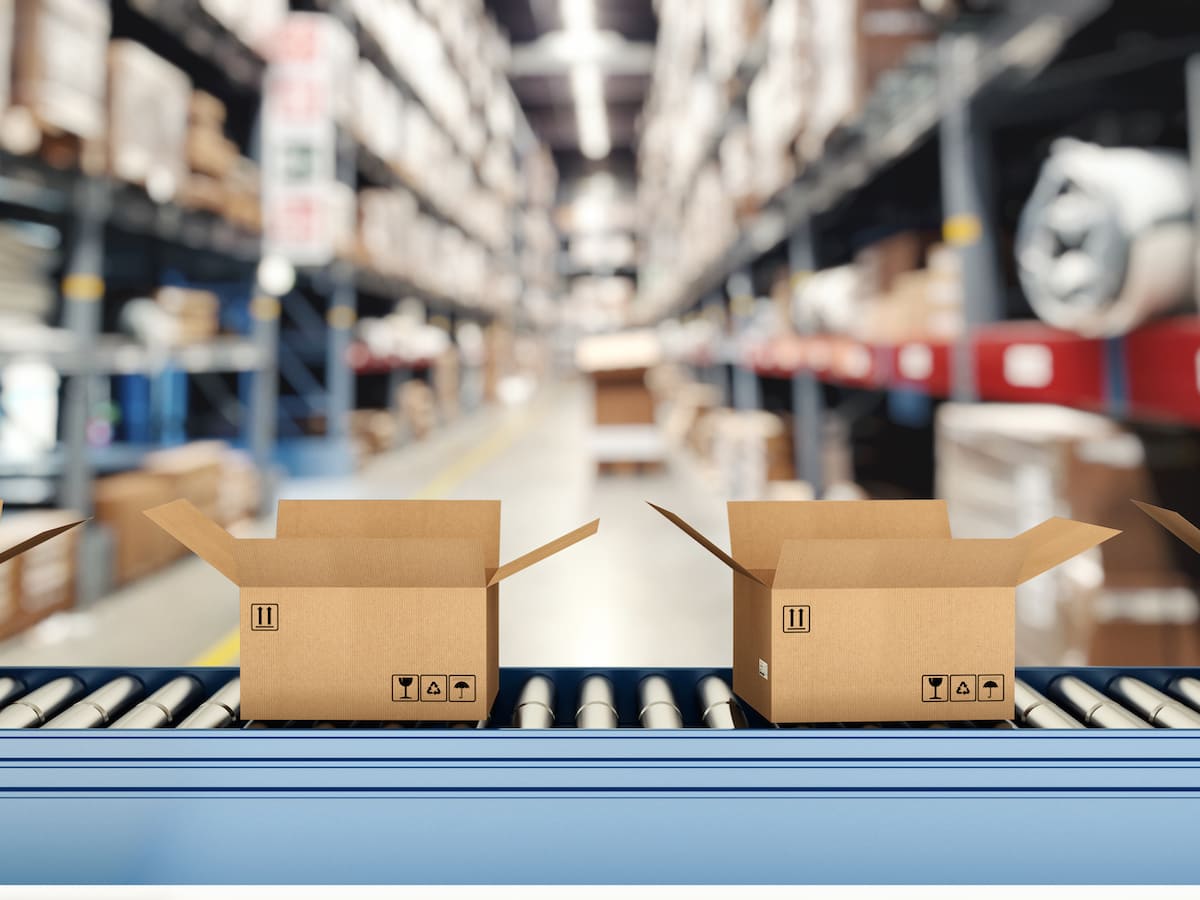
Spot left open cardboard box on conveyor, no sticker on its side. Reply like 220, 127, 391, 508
146, 500, 599, 721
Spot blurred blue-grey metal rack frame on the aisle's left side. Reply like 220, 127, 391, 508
0, 0, 552, 604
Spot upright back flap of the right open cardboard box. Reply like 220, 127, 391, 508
728, 500, 950, 569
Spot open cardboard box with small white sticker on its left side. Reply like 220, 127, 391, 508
652, 500, 1118, 722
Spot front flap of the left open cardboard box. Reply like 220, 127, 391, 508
233, 538, 486, 588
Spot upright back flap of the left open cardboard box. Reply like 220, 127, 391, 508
275, 500, 500, 569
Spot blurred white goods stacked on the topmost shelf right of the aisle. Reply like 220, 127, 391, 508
638, 0, 935, 311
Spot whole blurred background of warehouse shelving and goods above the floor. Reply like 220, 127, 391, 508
0, 0, 1200, 665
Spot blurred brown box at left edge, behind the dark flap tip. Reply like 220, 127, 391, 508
0, 504, 83, 638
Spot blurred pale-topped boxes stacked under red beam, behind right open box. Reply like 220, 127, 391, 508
936, 404, 1200, 665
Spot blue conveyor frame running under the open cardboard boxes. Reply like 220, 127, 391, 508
0, 668, 1200, 883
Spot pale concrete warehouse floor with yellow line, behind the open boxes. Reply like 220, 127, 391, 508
0, 384, 732, 666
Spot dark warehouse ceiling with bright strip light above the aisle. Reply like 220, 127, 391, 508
487, 0, 658, 172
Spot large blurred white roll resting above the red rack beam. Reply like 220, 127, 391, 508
1016, 138, 1195, 337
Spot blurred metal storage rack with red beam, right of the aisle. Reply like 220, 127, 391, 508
640, 0, 1200, 494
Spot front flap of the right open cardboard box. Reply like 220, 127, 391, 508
774, 538, 1026, 588
